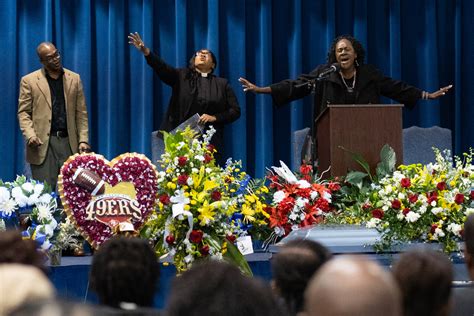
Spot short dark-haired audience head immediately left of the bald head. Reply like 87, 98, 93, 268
271, 240, 331, 314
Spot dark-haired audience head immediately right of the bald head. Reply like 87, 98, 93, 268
393, 249, 453, 315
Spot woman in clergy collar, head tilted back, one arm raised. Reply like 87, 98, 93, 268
128, 32, 240, 165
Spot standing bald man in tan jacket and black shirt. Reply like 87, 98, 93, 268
18, 42, 90, 189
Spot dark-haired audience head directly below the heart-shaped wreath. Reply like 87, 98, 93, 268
90, 236, 160, 308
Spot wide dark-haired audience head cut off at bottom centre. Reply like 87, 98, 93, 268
167, 261, 282, 316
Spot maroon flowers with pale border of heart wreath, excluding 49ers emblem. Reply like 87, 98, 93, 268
58, 153, 158, 248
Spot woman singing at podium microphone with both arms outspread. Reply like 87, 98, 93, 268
239, 35, 452, 132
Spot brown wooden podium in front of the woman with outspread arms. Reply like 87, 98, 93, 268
315, 104, 403, 177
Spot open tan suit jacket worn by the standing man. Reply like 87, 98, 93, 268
18, 68, 89, 165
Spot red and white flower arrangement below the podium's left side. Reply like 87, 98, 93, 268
267, 161, 340, 241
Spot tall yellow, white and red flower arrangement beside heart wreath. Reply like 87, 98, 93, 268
141, 128, 250, 273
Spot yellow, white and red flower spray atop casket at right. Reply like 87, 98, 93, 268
344, 149, 474, 252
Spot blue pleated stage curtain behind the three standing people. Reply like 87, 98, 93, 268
0, 0, 474, 180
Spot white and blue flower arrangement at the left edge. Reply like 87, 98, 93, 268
0, 176, 61, 250
